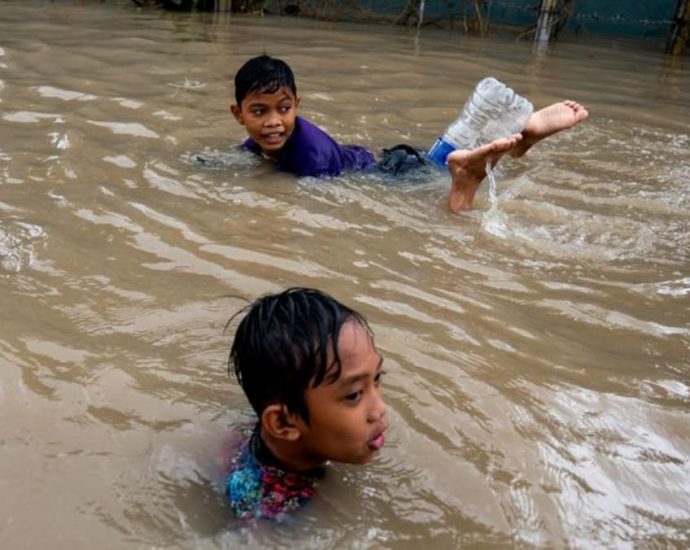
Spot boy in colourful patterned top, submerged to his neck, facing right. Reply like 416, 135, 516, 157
226, 288, 388, 519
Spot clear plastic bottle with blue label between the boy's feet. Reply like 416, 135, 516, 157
427, 77, 534, 165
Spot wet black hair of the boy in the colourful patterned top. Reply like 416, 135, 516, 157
228, 287, 373, 424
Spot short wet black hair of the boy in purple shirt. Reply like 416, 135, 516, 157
235, 55, 297, 106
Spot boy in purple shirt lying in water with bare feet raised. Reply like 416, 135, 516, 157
230, 55, 587, 212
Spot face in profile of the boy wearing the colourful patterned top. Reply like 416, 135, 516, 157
299, 321, 388, 464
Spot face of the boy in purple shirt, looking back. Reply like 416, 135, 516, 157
230, 87, 299, 155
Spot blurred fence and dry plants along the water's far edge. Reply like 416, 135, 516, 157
127, 0, 690, 54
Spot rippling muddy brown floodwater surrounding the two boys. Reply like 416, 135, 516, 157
0, 0, 690, 549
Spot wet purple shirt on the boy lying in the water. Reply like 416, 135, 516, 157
242, 117, 376, 177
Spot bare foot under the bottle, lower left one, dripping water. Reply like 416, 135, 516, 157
446, 134, 522, 213
